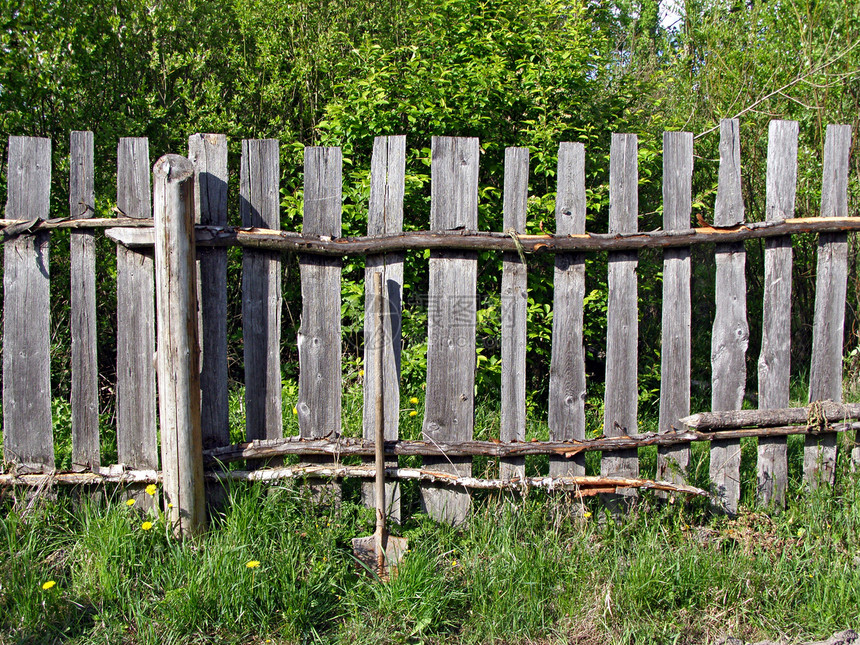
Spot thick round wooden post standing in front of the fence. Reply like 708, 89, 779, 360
152, 155, 206, 537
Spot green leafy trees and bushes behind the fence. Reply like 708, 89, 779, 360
0, 0, 860, 412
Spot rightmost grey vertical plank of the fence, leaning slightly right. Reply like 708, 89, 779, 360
803, 125, 851, 487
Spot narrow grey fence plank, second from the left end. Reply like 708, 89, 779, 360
69, 132, 101, 471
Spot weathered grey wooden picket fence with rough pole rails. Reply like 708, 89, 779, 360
0, 120, 860, 530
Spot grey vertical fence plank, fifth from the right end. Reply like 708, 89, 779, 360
600, 134, 639, 477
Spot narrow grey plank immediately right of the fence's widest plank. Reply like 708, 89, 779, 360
499, 148, 529, 479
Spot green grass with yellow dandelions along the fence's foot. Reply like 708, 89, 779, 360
0, 462, 860, 645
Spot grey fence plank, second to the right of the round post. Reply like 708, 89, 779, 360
239, 139, 284, 441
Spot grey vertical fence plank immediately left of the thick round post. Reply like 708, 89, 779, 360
116, 138, 158, 494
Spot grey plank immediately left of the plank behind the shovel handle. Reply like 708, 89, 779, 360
297, 148, 342, 437
